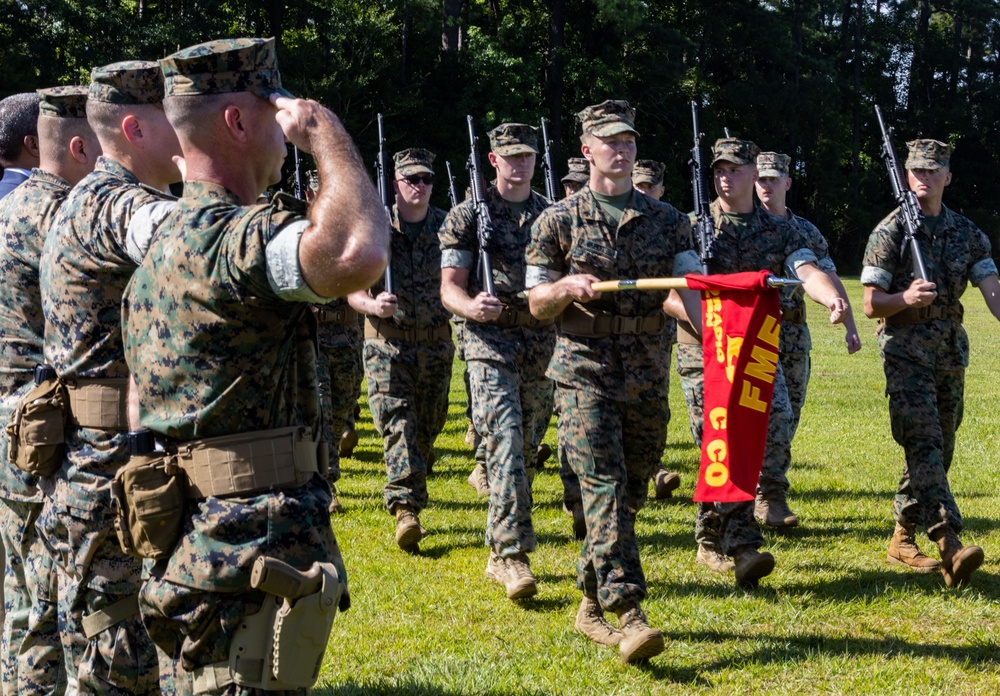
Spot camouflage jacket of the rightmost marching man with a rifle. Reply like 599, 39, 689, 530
861, 206, 997, 370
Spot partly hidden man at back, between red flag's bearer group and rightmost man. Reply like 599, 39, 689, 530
756, 152, 861, 440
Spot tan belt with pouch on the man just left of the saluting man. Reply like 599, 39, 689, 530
6, 365, 128, 476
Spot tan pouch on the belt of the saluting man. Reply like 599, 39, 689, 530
112, 452, 185, 560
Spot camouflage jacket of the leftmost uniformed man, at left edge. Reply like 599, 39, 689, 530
0, 169, 70, 502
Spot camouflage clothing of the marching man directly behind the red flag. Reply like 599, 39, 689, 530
677, 200, 817, 555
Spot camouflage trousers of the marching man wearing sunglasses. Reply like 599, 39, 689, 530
364, 339, 455, 512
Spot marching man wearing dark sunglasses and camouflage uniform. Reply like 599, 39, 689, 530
349, 148, 455, 552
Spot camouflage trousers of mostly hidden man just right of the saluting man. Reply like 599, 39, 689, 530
316, 323, 364, 483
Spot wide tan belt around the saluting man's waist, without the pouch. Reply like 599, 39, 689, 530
175, 426, 319, 499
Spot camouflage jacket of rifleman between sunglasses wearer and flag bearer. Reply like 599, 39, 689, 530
438, 186, 555, 361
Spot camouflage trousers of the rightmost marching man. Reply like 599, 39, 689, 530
882, 354, 965, 534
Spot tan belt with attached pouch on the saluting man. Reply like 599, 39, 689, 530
112, 426, 329, 559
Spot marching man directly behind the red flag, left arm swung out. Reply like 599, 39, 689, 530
677, 138, 847, 587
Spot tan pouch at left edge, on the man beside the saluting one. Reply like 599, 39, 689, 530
7, 377, 69, 476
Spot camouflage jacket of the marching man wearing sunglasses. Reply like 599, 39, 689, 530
371, 206, 451, 330
